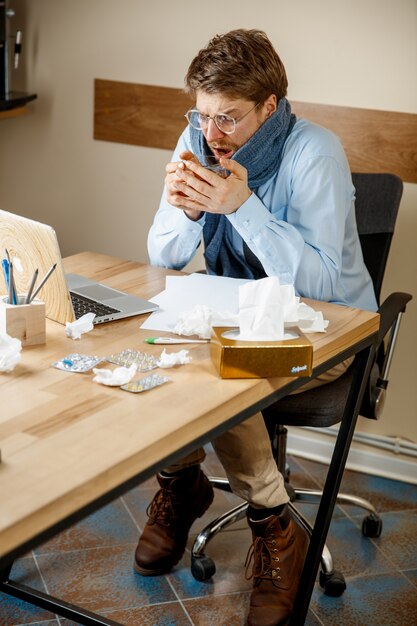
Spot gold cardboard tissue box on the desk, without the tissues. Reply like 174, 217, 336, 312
210, 326, 313, 378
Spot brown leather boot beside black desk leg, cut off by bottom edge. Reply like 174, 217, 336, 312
246, 507, 308, 626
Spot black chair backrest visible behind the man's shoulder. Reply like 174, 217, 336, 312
352, 174, 403, 304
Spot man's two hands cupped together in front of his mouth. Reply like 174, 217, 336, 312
165, 152, 251, 220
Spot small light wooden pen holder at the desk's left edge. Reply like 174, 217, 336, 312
0, 295, 45, 347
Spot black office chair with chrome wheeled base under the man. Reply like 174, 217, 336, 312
191, 174, 412, 596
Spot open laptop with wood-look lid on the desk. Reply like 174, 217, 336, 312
0, 209, 159, 324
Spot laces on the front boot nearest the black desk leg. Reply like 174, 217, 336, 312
245, 529, 281, 585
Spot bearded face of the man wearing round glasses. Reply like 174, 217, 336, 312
196, 91, 276, 159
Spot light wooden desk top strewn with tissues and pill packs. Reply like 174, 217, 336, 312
0, 253, 379, 623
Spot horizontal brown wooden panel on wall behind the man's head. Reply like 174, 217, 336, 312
94, 79, 417, 183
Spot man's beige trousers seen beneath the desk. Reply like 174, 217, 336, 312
166, 357, 353, 508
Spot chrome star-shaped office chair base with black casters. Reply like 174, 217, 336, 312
191, 477, 382, 597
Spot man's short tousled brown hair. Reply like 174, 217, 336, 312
185, 29, 288, 103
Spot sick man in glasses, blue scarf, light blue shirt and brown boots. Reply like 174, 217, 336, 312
135, 30, 376, 626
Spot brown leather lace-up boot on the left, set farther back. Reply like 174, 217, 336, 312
134, 465, 214, 576
